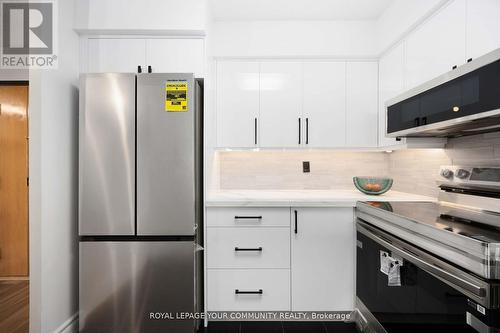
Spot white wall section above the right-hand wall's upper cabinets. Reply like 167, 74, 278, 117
374, 0, 449, 54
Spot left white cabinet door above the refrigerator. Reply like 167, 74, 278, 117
87, 38, 146, 73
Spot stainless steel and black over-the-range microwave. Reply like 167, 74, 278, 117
386, 49, 500, 138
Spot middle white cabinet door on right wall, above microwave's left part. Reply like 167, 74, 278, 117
406, 0, 465, 89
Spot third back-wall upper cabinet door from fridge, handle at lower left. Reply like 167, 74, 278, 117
303, 62, 346, 148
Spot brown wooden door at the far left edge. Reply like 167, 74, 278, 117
0, 83, 28, 277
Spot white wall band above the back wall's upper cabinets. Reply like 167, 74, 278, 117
209, 21, 376, 57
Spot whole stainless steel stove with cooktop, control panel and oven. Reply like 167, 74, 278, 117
356, 167, 500, 333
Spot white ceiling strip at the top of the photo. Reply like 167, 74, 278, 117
210, 0, 394, 21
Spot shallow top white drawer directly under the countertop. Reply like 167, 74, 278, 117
207, 207, 290, 227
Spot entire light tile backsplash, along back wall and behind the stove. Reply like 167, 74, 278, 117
215, 133, 500, 196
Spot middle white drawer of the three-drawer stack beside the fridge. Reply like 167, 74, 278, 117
206, 227, 290, 268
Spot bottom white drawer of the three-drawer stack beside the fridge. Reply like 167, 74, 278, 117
207, 269, 290, 311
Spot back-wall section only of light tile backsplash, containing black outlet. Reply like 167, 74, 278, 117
217, 150, 389, 190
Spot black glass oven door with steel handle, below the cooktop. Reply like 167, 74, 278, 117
356, 219, 500, 333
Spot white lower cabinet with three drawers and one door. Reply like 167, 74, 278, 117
206, 207, 355, 311
